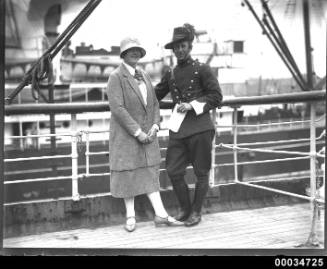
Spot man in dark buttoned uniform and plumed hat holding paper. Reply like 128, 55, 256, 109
155, 24, 222, 226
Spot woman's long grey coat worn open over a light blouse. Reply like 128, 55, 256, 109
107, 64, 161, 171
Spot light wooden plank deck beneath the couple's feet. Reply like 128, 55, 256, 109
3, 203, 324, 249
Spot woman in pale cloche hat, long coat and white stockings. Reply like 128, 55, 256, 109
107, 38, 183, 232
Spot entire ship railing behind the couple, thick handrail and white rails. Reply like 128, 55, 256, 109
4, 91, 326, 247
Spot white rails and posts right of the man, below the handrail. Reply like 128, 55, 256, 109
210, 102, 326, 247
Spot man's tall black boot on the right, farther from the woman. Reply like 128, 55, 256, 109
184, 177, 209, 227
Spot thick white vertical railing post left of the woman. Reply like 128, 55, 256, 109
71, 114, 79, 201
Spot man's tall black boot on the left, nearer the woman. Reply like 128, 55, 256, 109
171, 177, 191, 221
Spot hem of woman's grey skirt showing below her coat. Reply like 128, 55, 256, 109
110, 165, 160, 198
